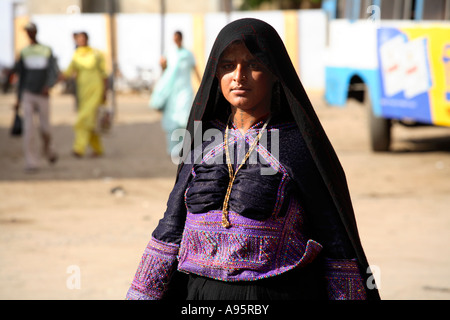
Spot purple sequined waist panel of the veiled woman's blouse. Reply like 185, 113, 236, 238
178, 201, 322, 281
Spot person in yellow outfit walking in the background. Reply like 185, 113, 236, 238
64, 32, 107, 157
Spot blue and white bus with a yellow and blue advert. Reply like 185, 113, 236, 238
323, 0, 450, 151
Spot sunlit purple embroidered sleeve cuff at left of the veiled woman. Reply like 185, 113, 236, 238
126, 237, 179, 300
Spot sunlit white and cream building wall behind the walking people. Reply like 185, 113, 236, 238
0, 0, 327, 90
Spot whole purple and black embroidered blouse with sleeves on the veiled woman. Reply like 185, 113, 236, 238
127, 121, 365, 299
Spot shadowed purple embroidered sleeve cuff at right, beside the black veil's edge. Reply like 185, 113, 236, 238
325, 259, 366, 300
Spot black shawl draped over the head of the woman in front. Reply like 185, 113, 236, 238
180, 18, 378, 299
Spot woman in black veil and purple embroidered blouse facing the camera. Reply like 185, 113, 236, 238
127, 19, 379, 300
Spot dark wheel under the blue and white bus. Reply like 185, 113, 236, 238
364, 91, 392, 152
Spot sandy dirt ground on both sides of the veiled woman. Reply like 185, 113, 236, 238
0, 92, 450, 300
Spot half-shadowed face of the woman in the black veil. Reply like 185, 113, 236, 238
217, 42, 275, 112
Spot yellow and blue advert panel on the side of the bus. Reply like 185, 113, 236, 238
377, 24, 450, 126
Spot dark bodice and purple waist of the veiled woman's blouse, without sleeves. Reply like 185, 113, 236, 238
178, 123, 322, 281
